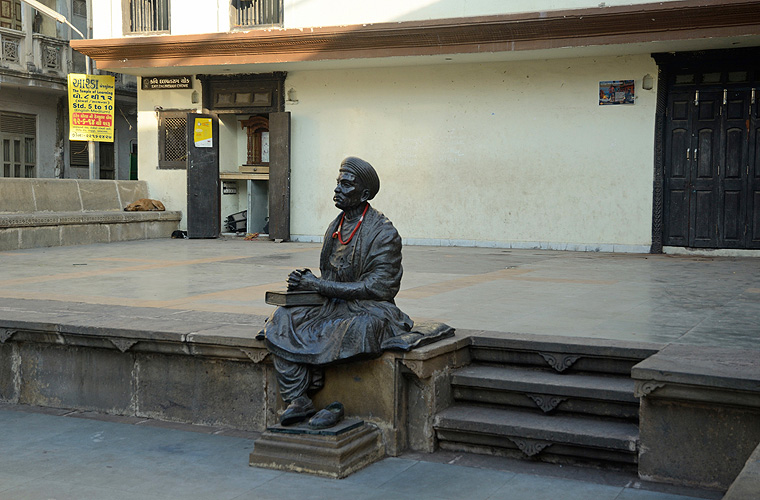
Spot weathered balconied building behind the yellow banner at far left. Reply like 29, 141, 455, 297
0, 0, 137, 179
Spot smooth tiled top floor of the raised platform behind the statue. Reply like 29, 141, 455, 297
0, 237, 760, 349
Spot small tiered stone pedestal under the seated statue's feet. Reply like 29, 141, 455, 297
250, 419, 385, 479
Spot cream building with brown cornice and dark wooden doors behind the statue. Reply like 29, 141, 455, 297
72, 0, 760, 252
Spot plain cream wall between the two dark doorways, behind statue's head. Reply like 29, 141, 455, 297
286, 56, 656, 247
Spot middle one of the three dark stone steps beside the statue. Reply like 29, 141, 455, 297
451, 364, 639, 420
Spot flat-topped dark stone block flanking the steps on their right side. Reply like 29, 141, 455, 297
631, 344, 760, 490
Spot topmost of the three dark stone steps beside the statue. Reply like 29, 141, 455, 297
470, 333, 664, 375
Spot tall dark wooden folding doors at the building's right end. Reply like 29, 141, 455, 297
653, 50, 760, 251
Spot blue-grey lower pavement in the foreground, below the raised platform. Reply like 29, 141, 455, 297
0, 405, 720, 500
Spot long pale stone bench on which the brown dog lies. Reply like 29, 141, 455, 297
0, 179, 182, 251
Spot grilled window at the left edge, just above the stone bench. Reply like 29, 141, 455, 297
0, 113, 37, 177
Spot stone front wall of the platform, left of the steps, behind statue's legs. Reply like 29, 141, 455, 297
0, 309, 469, 456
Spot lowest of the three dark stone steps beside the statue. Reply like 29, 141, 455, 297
434, 404, 639, 466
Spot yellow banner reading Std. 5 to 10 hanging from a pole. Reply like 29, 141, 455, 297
69, 73, 115, 142
